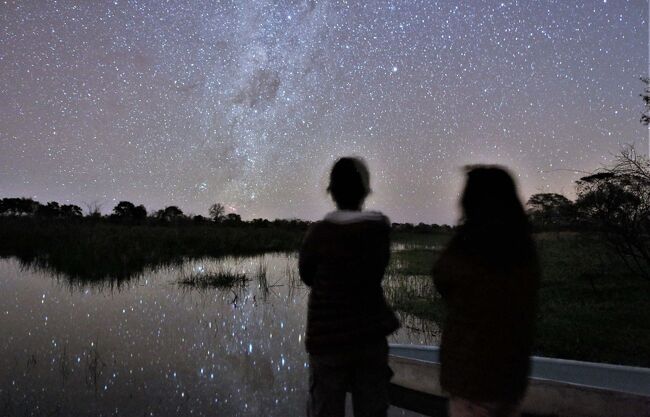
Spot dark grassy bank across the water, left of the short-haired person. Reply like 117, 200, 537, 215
0, 217, 304, 283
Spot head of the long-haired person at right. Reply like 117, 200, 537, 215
461, 165, 527, 228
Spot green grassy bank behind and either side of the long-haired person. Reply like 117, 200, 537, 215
387, 233, 650, 367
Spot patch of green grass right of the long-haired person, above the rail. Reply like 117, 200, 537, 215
535, 235, 650, 366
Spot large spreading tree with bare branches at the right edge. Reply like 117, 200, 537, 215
576, 146, 650, 279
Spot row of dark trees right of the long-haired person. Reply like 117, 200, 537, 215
527, 145, 650, 279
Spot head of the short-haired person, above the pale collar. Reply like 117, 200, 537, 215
327, 157, 370, 210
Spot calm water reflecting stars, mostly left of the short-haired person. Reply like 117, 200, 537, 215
0, 254, 438, 416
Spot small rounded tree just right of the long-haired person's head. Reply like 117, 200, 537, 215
526, 193, 575, 229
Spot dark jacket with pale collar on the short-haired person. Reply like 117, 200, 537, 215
299, 212, 399, 354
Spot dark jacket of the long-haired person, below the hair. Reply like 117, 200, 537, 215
433, 231, 539, 402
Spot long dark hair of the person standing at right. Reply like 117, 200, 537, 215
457, 165, 535, 268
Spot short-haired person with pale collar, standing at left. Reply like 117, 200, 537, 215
299, 158, 399, 417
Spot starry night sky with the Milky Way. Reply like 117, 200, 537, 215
0, 0, 649, 223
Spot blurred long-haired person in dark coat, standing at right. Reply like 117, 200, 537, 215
433, 166, 539, 417
